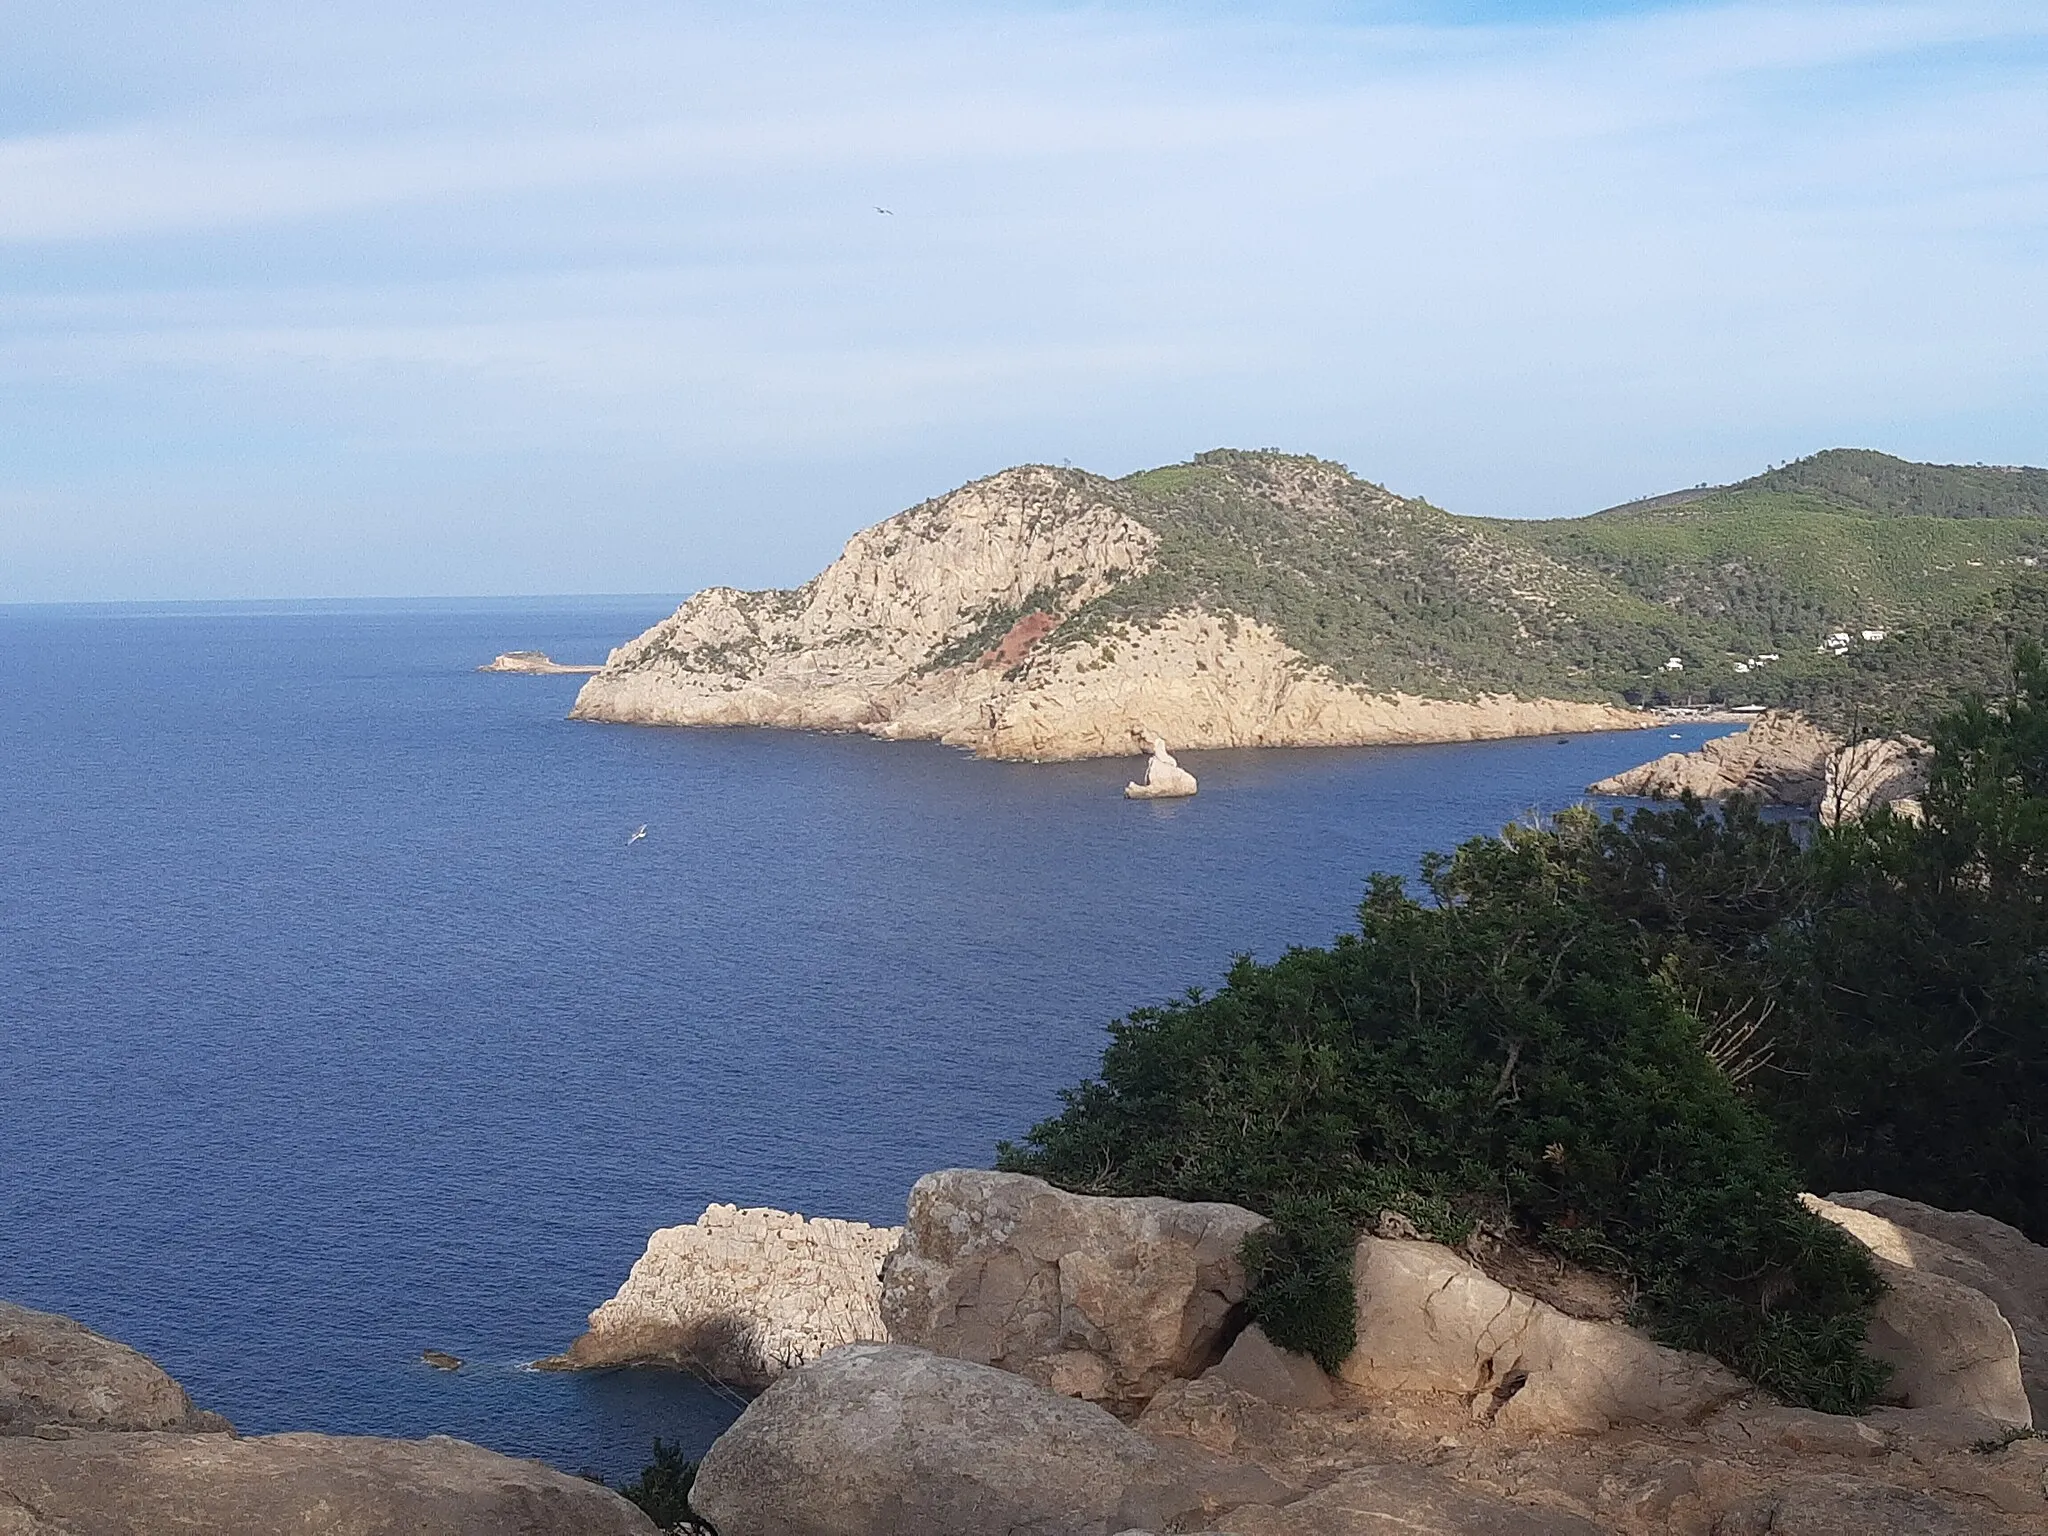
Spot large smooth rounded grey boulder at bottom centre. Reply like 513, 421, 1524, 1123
690, 1343, 1290, 1536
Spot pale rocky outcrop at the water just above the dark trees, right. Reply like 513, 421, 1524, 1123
1587, 711, 1927, 825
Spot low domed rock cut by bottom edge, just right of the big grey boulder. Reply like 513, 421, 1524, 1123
1217, 1466, 1599, 1536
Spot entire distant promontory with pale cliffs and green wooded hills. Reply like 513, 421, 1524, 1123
565, 451, 2048, 760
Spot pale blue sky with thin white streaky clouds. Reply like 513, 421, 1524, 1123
0, 0, 2048, 602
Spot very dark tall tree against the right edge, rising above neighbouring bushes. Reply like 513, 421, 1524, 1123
1759, 647, 2048, 1243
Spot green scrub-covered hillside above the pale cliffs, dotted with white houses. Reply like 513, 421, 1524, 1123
1063, 451, 2048, 727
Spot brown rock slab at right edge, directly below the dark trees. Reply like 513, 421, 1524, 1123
1827, 1190, 2048, 1425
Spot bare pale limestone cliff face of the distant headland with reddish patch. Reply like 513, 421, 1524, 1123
573, 467, 1645, 760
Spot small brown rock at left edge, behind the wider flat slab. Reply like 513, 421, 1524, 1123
0, 1300, 214, 1436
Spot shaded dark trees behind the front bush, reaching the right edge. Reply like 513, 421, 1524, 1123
1507, 643, 2048, 1243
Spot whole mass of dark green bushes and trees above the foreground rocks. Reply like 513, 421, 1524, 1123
1004, 647, 2048, 1411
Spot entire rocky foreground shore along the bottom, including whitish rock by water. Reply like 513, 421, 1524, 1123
0, 1169, 2048, 1536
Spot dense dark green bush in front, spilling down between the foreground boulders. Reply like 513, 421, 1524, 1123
1001, 835, 1884, 1411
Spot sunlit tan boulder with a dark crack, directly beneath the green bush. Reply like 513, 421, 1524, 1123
1337, 1237, 1751, 1434
